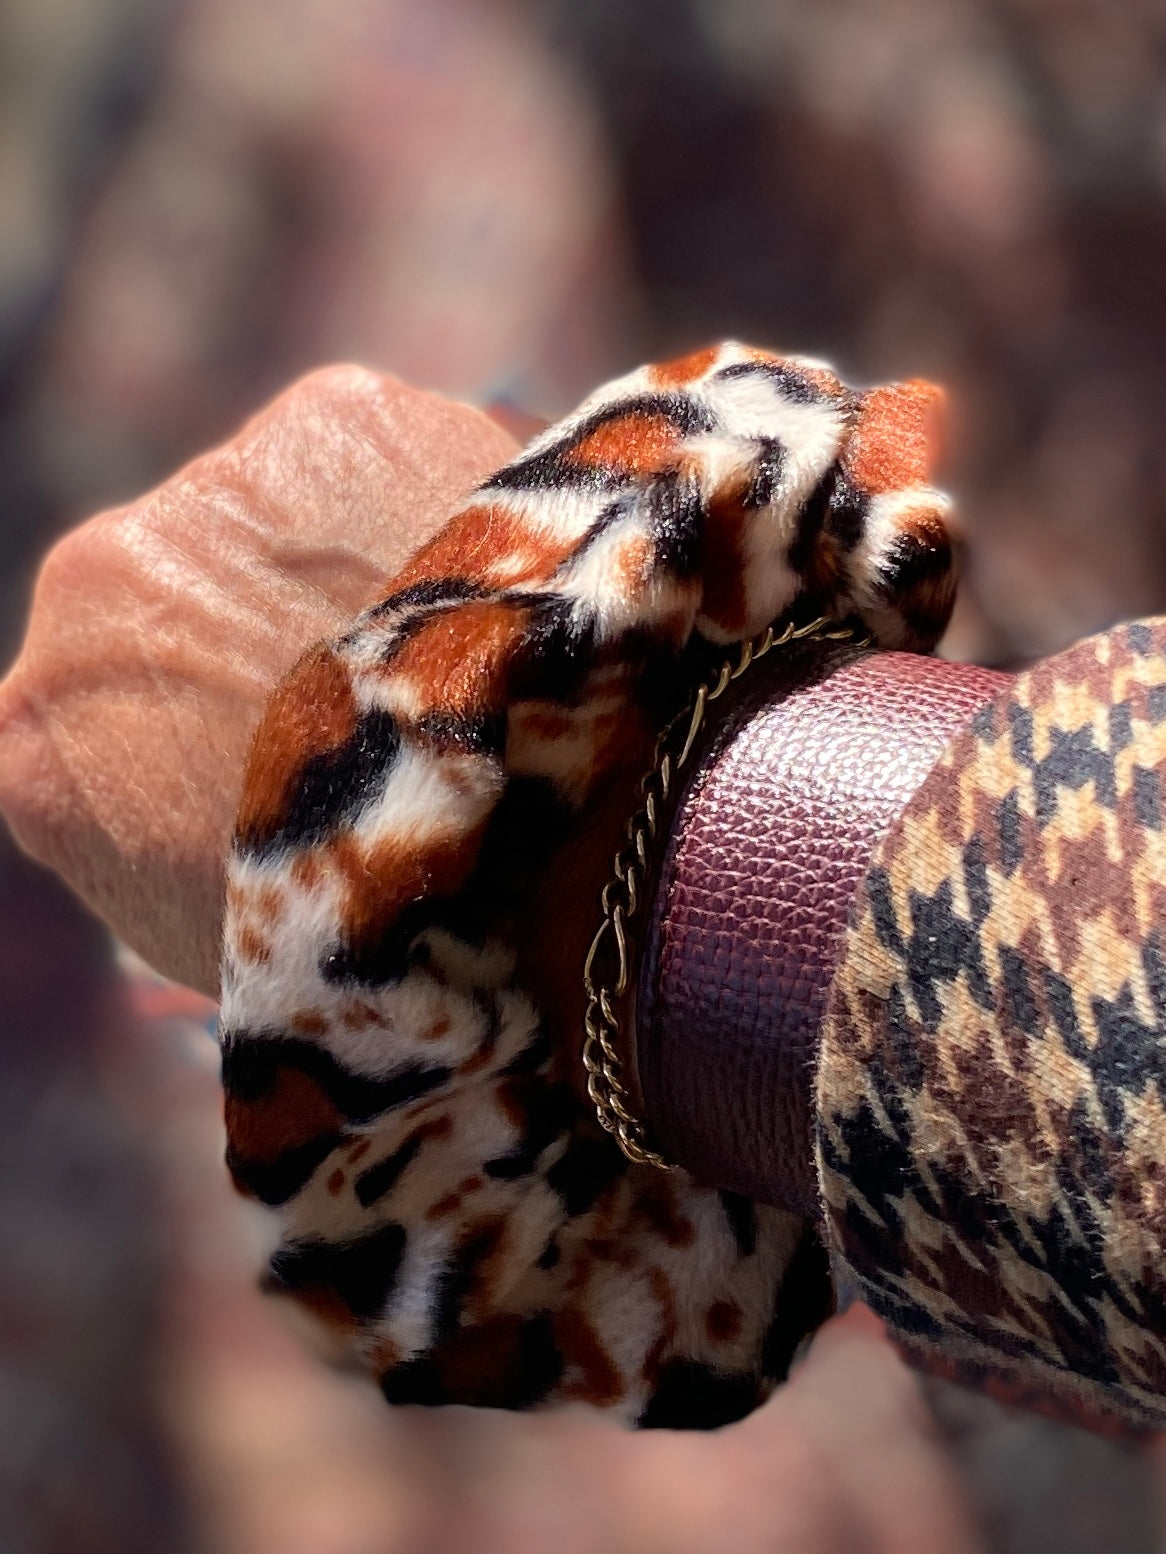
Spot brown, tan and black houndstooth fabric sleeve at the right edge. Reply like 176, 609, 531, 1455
818, 622, 1166, 1430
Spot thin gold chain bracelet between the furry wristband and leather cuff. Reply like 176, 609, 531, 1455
583, 615, 863, 1170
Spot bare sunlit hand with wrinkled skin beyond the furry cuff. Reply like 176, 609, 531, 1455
0, 367, 516, 995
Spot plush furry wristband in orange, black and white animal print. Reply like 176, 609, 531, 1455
221, 345, 953, 1427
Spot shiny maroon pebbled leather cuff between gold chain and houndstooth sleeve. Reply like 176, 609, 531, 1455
636, 643, 1006, 1215
